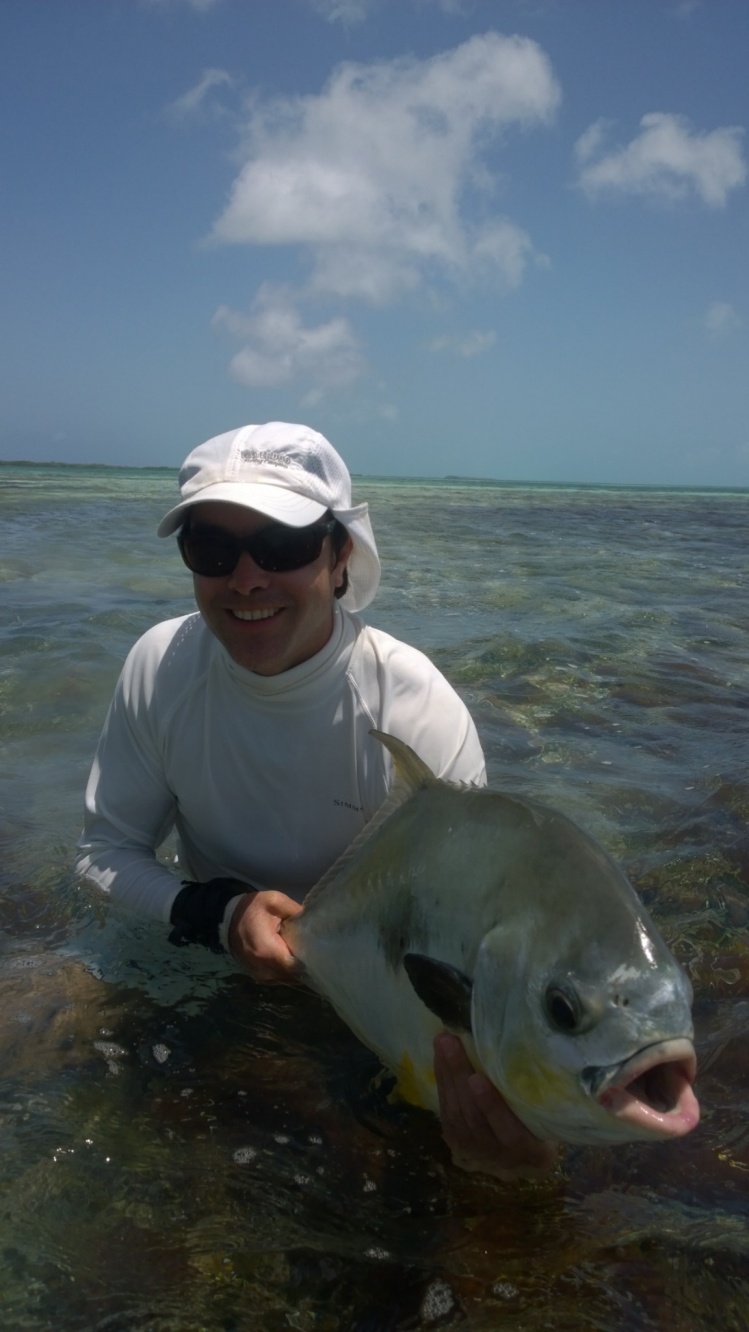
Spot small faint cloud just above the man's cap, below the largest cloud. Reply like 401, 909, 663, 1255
213, 286, 365, 401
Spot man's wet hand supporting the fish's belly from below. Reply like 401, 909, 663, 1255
434, 1031, 557, 1180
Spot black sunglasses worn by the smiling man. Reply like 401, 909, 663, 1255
177, 518, 336, 578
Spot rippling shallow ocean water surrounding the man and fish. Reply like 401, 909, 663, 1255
0, 464, 749, 1332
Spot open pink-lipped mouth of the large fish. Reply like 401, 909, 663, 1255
582, 1036, 700, 1138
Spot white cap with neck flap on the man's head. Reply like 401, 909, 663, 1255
157, 421, 380, 610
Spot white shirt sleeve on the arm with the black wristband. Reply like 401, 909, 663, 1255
76, 628, 181, 922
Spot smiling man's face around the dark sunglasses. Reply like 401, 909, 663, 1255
191, 501, 352, 675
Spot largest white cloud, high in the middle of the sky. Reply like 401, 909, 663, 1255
206, 32, 560, 304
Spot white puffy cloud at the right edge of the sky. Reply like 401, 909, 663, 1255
576, 112, 746, 208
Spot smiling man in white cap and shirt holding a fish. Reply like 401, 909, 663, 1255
77, 422, 550, 1173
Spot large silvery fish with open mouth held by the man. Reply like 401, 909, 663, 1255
281, 731, 700, 1146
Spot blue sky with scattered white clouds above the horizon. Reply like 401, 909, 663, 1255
0, 0, 749, 486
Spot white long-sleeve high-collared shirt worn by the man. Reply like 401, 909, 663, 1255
76, 605, 486, 922
